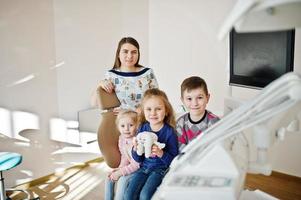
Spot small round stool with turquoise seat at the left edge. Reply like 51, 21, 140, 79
0, 152, 37, 200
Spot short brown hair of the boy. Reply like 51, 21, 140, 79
181, 76, 208, 98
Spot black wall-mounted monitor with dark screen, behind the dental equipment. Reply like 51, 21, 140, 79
230, 29, 295, 88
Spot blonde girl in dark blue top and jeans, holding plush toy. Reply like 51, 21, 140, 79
124, 89, 178, 200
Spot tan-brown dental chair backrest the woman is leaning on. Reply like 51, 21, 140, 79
97, 88, 121, 168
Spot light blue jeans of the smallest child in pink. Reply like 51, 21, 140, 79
105, 174, 132, 200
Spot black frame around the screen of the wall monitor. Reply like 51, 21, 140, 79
229, 29, 295, 89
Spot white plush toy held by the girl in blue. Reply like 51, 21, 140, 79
136, 131, 165, 158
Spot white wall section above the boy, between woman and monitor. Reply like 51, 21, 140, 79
149, 0, 234, 114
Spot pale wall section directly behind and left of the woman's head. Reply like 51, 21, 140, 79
54, 0, 148, 120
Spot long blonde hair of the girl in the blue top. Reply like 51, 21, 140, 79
139, 88, 176, 128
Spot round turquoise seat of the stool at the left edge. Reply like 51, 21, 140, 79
0, 152, 22, 171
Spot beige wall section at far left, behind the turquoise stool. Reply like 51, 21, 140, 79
0, 0, 58, 186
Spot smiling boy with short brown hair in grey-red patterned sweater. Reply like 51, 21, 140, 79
176, 76, 219, 151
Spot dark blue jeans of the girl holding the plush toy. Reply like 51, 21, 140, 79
124, 167, 167, 200
